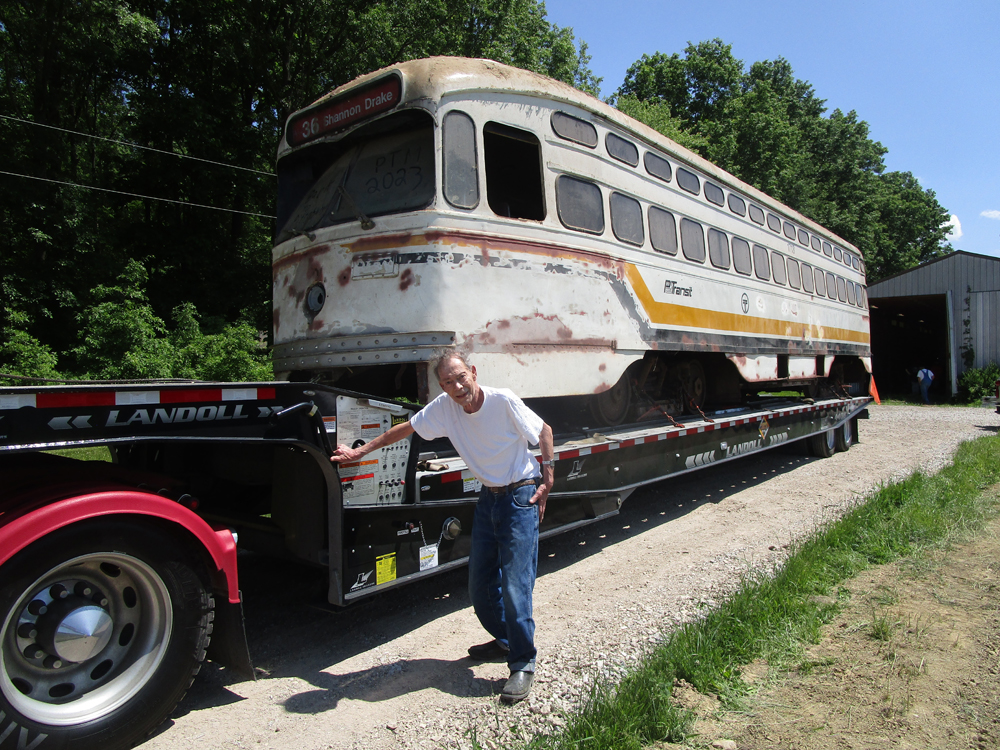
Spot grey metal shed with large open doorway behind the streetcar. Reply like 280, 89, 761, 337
868, 251, 1000, 398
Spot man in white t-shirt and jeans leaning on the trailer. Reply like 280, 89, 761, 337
331, 352, 554, 703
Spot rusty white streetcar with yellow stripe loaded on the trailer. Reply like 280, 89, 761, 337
273, 58, 871, 424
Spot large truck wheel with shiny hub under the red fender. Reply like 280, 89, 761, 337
0, 519, 215, 750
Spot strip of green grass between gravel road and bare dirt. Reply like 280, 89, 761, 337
520, 437, 1000, 750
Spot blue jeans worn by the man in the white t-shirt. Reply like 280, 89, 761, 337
469, 484, 538, 672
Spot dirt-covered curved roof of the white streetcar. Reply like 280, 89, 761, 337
278, 57, 862, 257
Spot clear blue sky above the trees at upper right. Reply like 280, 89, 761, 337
545, 0, 1000, 256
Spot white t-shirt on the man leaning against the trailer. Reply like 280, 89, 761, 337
410, 386, 545, 487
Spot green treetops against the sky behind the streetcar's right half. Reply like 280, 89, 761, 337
611, 39, 951, 283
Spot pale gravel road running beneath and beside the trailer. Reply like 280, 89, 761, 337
143, 406, 1000, 750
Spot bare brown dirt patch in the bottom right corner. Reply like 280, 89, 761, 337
684, 502, 1000, 750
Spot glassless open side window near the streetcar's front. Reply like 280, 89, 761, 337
483, 122, 544, 221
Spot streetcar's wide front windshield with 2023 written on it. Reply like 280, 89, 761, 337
275, 111, 436, 242
